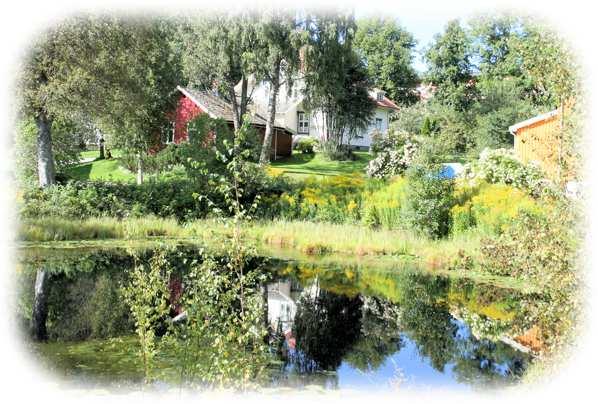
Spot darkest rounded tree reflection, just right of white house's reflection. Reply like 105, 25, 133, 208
293, 289, 362, 372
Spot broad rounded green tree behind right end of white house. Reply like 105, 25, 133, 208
354, 18, 418, 105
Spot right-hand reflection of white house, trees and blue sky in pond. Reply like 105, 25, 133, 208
268, 266, 529, 388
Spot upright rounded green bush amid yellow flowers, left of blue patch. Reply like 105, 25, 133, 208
404, 165, 454, 238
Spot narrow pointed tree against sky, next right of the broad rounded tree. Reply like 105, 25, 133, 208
425, 20, 475, 110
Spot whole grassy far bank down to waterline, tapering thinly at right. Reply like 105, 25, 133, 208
19, 217, 536, 291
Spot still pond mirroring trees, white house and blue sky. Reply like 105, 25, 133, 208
17, 246, 534, 391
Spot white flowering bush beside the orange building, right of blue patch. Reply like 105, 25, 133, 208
461, 148, 554, 196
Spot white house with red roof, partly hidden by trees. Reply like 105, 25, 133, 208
241, 80, 399, 149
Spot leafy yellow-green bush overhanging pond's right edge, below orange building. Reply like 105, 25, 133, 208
481, 201, 582, 351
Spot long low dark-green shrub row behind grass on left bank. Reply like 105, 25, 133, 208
20, 163, 288, 221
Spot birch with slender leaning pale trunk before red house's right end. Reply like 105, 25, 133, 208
257, 10, 301, 164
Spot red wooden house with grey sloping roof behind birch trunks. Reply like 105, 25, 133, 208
163, 86, 293, 159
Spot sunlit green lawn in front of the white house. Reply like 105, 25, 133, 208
272, 152, 372, 177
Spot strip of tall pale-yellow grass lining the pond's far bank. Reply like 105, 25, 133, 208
18, 217, 478, 267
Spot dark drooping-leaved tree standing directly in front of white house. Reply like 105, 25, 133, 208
303, 13, 374, 157
